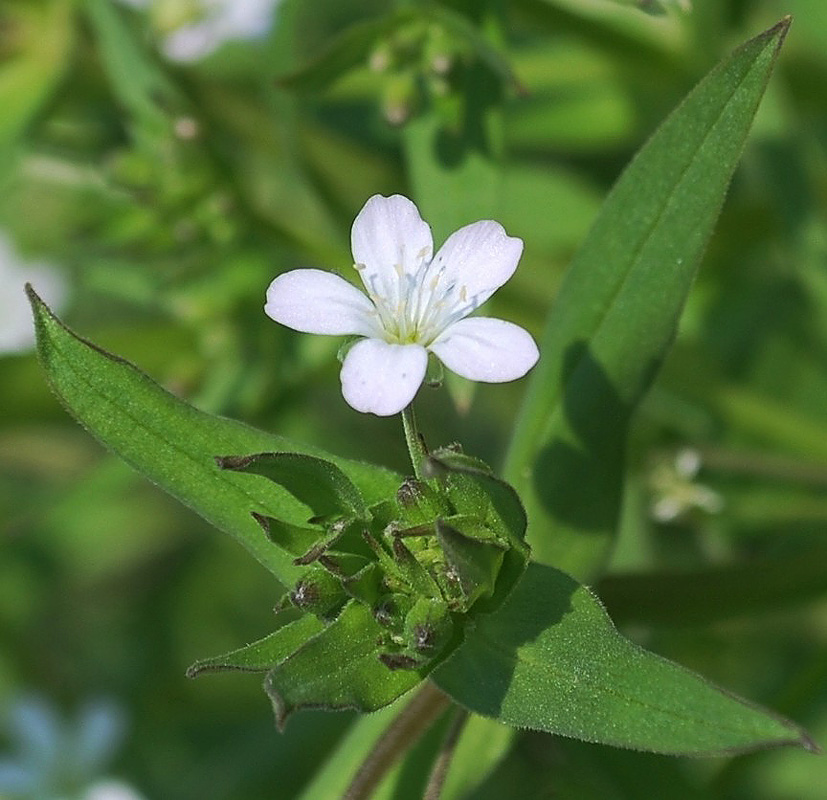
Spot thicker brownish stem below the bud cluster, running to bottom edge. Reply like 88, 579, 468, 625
342, 681, 451, 800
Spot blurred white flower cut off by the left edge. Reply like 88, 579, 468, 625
0, 231, 67, 355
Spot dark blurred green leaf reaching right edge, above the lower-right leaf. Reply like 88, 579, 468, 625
597, 545, 827, 625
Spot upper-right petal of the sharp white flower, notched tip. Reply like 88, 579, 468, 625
423, 219, 523, 316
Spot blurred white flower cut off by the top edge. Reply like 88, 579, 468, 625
115, 0, 281, 62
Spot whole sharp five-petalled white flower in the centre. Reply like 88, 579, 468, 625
264, 195, 539, 416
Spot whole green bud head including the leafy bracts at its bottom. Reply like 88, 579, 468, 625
193, 448, 528, 723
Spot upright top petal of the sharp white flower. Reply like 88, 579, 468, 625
350, 194, 434, 308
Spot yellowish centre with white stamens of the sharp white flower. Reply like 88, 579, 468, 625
354, 247, 480, 347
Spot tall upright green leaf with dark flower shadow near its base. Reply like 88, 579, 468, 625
504, 19, 789, 579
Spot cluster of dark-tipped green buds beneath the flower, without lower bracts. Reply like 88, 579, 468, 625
219, 448, 528, 674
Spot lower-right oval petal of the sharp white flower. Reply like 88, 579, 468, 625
428, 317, 540, 383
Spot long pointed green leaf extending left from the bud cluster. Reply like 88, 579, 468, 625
28, 287, 401, 585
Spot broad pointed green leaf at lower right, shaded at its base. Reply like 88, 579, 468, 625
432, 564, 817, 755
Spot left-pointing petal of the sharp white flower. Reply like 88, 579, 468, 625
264, 269, 379, 336
